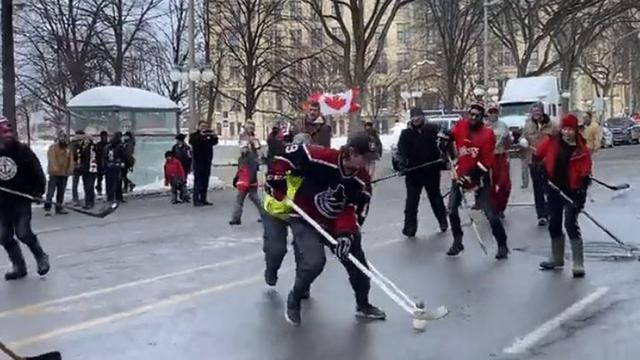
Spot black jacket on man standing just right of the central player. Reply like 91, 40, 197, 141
398, 123, 444, 178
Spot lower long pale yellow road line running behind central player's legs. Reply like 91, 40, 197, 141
9, 235, 404, 349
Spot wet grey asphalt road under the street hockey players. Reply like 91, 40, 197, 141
0, 146, 640, 360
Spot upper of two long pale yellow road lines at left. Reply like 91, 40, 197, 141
0, 252, 263, 318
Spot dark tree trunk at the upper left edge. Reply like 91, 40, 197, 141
2, 0, 18, 136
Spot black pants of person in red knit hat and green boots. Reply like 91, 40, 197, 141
547, 189, 582, 239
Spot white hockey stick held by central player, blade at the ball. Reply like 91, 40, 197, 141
286, 199, 449, 321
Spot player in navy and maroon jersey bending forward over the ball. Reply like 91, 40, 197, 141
266, 133, 386, 325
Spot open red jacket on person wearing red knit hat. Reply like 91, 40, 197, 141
536, 135, 592, 190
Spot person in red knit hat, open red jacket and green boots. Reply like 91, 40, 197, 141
536, 114, 592, 278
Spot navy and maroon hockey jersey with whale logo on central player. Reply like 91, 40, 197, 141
269, 144, 371, 235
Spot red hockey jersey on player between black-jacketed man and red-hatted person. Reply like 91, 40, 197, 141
451, 119, 496, 185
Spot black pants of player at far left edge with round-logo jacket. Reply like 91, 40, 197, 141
0, 200, 44, 263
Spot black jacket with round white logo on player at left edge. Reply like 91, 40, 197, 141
0, 141, 47, 204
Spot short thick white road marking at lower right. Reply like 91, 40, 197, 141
502, 287, 609, 354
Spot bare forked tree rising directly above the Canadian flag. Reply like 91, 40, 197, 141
302, 0, 415, 131
